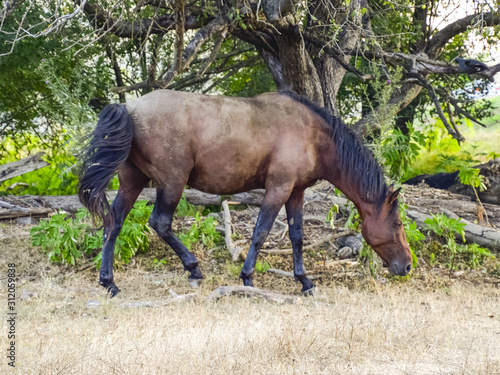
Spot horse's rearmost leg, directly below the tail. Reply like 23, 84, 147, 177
99, 161, 149, 297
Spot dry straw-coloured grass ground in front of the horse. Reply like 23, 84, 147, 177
0, 234, 500, 375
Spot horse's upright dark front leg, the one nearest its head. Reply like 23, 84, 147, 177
285, 191, 315, 294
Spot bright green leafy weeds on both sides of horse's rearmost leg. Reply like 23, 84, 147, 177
31, 201, 153, 267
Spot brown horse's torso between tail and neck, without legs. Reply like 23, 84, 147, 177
127, 90, 324, 194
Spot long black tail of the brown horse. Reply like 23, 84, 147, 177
78, 104, 134, 226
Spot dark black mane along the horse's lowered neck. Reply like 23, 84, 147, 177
279, 90, 388, 205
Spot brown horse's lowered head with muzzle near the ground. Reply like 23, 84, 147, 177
361, 186, 412, 276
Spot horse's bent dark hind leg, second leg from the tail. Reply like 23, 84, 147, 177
149, 184, 203, 285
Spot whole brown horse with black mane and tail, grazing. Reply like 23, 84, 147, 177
79, 90, 412, 295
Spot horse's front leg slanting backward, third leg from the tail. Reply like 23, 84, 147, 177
240, 189, 290, 286
